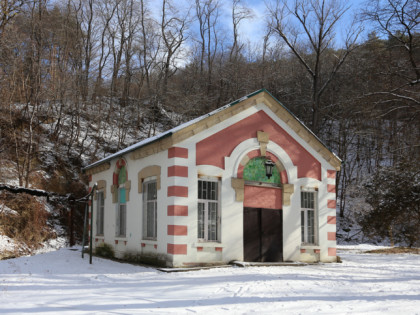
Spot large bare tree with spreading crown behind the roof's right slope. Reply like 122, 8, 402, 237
268, 0, 361, 133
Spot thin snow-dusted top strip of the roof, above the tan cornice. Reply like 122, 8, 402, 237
83, 89, 341, 170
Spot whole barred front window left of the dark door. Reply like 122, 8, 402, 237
197, 179, 220, 241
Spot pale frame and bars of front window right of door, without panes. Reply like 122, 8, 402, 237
300, 188, 319, 246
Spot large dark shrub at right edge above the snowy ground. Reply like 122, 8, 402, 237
360, 162, 420, 247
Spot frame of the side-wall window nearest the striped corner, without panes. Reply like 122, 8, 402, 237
142, 176, 158, 241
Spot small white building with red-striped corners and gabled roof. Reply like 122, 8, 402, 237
85, 90, 341, 267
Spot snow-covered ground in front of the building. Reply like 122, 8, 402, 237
0, 246, 420, 314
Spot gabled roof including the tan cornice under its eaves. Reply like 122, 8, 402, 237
84, 89, 341, 174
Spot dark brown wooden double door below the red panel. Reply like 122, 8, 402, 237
243, 207, 283, 262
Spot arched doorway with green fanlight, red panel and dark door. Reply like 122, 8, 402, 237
243, 156, 283, 262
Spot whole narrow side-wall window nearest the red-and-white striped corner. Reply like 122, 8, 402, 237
143, 180, 157, 240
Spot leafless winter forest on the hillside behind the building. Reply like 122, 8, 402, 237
0, 0, 420, 252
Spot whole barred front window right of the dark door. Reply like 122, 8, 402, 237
300, 191, 317, 245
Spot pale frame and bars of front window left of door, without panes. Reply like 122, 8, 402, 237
197, 176, 222, 243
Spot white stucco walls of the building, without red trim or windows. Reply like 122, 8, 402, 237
91, 104, 336, 266
